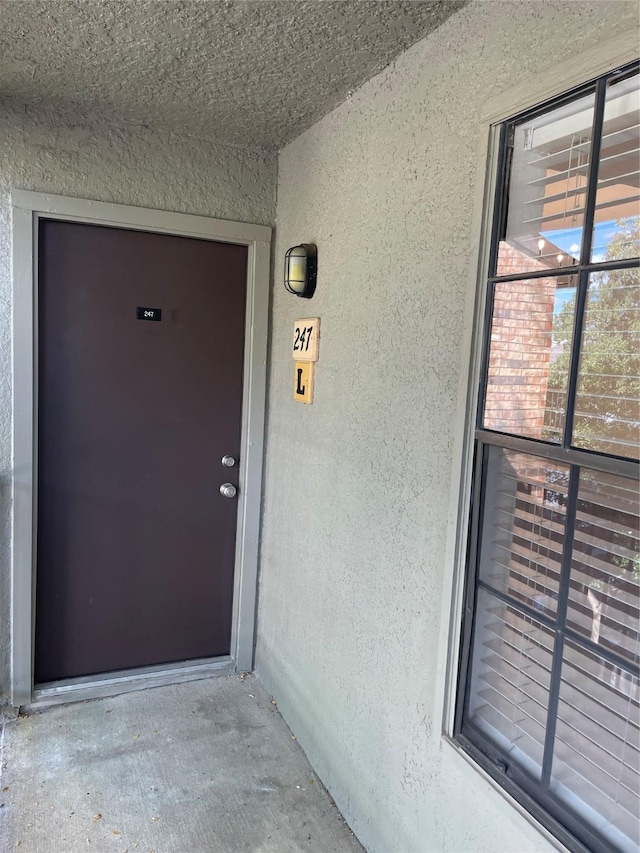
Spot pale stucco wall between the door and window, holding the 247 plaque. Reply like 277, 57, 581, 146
257, 2, 637, 853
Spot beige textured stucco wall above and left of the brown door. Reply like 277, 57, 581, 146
0, 101, 277, 704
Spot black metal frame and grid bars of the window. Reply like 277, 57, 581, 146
452, 61, 640, 853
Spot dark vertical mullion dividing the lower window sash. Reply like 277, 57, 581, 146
541, 465, 580, 788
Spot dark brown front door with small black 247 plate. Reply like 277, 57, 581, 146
35, 216, 247, 684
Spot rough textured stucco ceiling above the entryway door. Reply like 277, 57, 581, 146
0, 0, 464, 148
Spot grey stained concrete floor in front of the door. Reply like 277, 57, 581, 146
0, 676, 363, 853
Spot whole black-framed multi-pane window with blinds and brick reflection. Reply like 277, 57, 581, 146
455, 65, 640, 853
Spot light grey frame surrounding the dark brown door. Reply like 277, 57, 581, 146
11, 190, 271, 707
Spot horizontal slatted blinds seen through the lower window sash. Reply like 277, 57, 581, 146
468, 446, 640, 850
